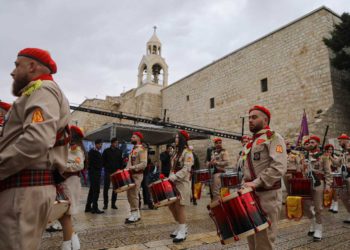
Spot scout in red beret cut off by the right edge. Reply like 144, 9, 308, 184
337, 134, 350, 224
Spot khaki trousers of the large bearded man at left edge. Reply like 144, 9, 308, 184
0, 185, 56, 250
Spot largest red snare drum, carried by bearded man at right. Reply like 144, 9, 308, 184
208, 188, 270, 244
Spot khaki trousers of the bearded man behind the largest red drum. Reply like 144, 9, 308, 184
247, 188, 282, 250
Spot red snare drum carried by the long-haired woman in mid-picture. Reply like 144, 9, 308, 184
148, 178, 179, 207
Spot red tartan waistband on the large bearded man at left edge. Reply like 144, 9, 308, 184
0, 169, 54, 192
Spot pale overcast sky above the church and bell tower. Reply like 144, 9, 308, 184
0, 0, 350, 103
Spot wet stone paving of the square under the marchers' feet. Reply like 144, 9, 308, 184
41, 188, 350, 250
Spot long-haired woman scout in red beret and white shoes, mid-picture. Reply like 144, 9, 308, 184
169, 130, 194, 243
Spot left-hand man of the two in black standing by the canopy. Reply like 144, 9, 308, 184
85, 139, 104, 214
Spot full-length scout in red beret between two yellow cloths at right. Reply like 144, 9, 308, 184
305, 135, 333, 241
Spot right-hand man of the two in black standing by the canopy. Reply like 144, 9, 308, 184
102, 138, 123, 209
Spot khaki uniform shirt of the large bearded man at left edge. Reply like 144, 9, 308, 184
0, 80, 70, 180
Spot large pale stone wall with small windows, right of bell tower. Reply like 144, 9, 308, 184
162, 8, 349, 160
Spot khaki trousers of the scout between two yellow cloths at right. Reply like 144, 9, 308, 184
304, 181, 324, 224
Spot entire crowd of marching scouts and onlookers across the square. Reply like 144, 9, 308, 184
0, 48, 350, 250
